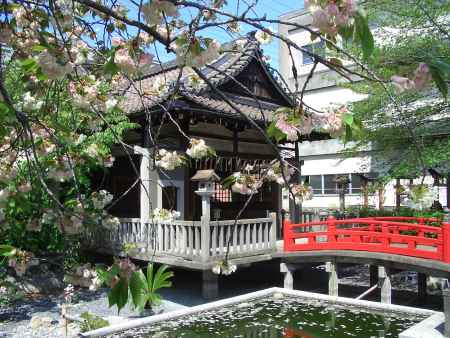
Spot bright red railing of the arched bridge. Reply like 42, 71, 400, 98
283, 217, 450, 263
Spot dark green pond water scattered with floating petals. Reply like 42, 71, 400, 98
109, 294, 426, 338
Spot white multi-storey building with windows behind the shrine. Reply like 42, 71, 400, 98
278, 10, 448, 209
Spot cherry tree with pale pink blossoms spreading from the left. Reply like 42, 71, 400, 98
0, 0, 448, 278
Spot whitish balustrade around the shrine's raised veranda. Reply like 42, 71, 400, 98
82, 213, 276, 263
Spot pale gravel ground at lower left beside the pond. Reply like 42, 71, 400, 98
0, 289, 185, 338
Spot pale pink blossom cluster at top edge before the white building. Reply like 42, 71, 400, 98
305, 0, 356, 37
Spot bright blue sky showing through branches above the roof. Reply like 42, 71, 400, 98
119, 0, 303, 68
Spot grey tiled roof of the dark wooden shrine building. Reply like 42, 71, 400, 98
121, 38, 288, 120
